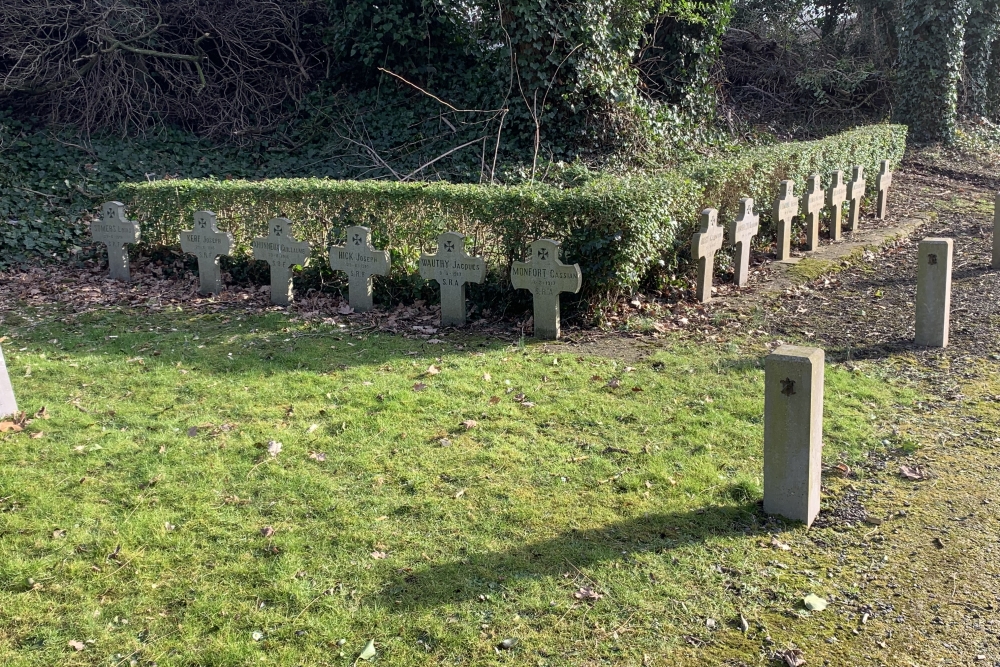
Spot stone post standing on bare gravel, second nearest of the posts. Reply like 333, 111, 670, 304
914, 238, 954, 347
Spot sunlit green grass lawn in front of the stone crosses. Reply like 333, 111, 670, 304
0, 310, 914, 666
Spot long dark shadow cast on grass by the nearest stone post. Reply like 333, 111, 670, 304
381, 501, 768, 608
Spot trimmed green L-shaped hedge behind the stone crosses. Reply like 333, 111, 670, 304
118, 125, 906, 303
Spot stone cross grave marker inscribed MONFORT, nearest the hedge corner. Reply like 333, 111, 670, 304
510, 239, 583, 340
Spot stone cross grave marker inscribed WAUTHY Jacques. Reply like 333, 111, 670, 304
420, 232, 486, 327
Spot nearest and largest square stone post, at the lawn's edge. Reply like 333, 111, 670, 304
764, 345, 824, 526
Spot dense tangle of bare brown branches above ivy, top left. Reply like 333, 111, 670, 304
0, 0, 320, 136
